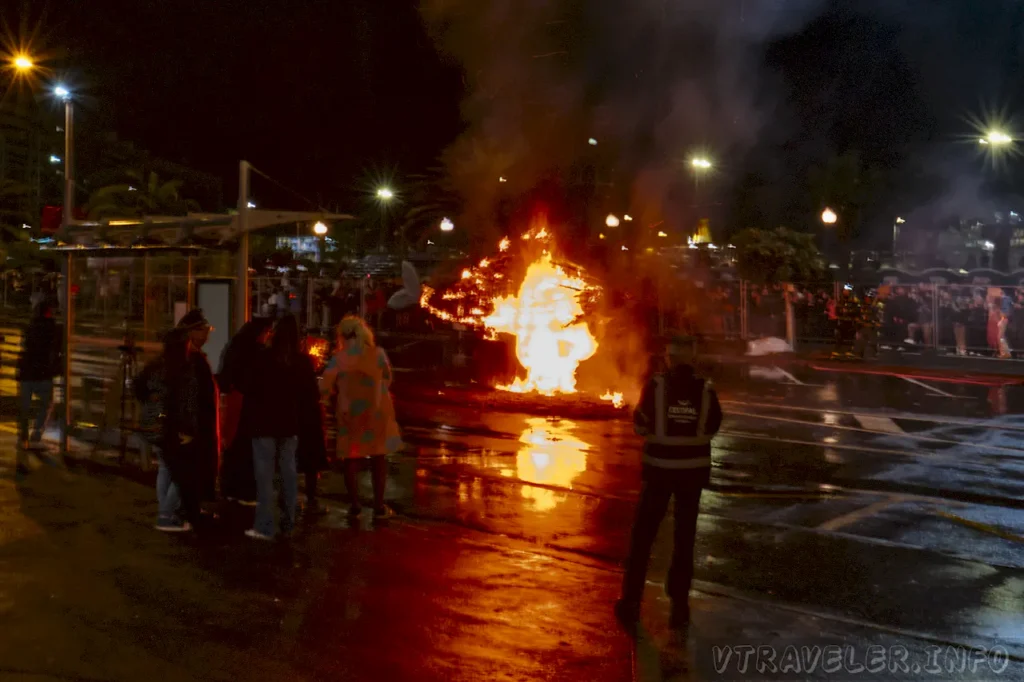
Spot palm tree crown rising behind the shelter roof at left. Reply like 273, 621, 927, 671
86, 170, 200, 219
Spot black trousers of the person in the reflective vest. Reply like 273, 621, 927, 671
623, 464, 711, 604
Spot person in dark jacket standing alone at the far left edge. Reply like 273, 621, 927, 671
17, 301, 62, 458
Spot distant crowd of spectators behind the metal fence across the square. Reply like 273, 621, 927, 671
3, 263, 1024, 355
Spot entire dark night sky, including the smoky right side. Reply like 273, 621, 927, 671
12, 0, 1024, 231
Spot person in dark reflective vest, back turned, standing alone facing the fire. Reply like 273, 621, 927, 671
615, 338, 722, 634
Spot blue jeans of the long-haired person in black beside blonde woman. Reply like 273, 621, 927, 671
253, 436, 299, 536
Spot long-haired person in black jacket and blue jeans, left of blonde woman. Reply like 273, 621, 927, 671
243, 314, 318, 540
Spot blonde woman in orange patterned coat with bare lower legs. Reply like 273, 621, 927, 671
321, 315, 401, 518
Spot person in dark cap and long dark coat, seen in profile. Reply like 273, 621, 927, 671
175, 308, 220, 502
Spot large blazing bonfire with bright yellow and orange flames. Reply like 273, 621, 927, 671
420, 220, 623, 407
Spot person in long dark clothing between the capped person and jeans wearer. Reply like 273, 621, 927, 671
217, 317, 272, 504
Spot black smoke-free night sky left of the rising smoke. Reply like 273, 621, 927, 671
18, 0, 460, 202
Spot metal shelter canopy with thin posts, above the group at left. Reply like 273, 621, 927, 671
49, 175, 354, 456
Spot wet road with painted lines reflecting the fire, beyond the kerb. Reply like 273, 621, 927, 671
391, 360, 1024, 670
